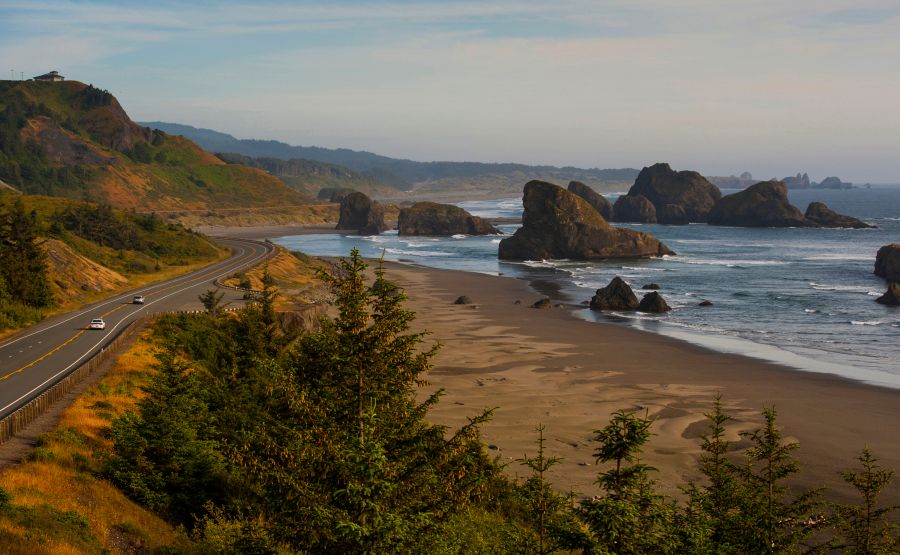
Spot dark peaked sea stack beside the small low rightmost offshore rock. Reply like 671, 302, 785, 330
707, 181, 818, 227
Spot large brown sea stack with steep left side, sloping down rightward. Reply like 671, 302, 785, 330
498, 181, 675, 260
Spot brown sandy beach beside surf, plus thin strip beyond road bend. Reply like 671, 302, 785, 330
204, 226, 900, 503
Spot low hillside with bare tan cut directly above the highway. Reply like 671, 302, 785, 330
0, 191, 224, 332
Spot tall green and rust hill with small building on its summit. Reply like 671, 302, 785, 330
0, 81, 309, 211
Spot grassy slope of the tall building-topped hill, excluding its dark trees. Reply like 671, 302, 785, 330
0, 81, 307, 210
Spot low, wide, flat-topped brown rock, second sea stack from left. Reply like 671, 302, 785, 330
397, 202, 500, 236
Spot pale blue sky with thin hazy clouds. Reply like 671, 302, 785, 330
0, 0, 900, 183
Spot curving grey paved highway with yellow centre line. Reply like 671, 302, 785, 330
0, 239, 273, 418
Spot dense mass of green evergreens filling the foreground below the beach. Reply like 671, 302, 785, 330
106, 252, 897, 554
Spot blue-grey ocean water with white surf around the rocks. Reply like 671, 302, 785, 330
276, 187, 900, 388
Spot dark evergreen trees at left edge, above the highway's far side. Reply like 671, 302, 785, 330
0, 199, 53, 330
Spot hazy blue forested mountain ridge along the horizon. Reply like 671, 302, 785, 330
141, 121, 638, 189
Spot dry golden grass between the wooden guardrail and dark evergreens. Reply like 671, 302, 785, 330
0, 332, 188, 553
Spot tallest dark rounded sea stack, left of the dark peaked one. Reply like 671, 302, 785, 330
614, 163, 722, 224
